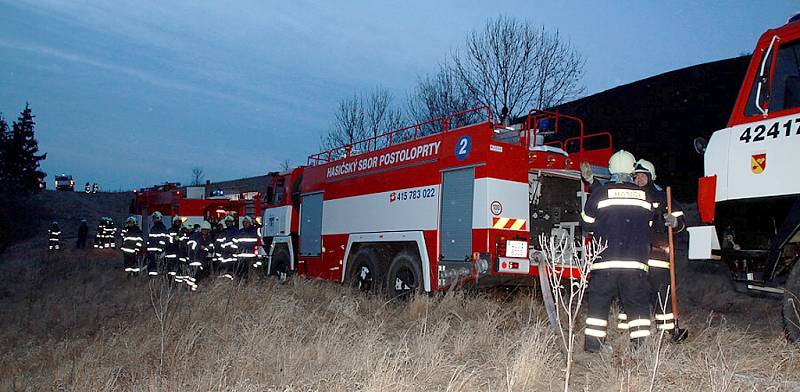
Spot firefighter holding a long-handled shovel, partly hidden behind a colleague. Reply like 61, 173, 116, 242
634, 159, 686, 341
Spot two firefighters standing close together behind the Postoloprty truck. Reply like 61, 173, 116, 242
581, 150, 686, 352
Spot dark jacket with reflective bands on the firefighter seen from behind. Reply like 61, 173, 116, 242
582, 181, 654, 271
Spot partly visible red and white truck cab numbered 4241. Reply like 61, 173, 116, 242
689, 15, 800, 340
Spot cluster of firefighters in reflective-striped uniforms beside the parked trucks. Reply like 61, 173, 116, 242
121, 212, 262, 291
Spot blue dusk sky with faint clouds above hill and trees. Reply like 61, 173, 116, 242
0, 0, 800, 190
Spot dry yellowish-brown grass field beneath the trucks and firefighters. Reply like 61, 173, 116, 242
0, 191, 800, 391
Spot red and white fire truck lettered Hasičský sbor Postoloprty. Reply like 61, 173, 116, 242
262, 107, 612, 296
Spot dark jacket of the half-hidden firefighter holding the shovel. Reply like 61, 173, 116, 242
645, 182, 684, 268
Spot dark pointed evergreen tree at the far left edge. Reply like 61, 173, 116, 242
2, 103, 47, 192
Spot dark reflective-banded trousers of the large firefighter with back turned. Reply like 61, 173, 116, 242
584, 268, 650, 352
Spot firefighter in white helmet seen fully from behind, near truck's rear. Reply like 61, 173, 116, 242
582, 150, 653, 352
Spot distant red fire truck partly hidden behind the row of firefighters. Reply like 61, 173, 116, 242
131, 183, 261, 228
